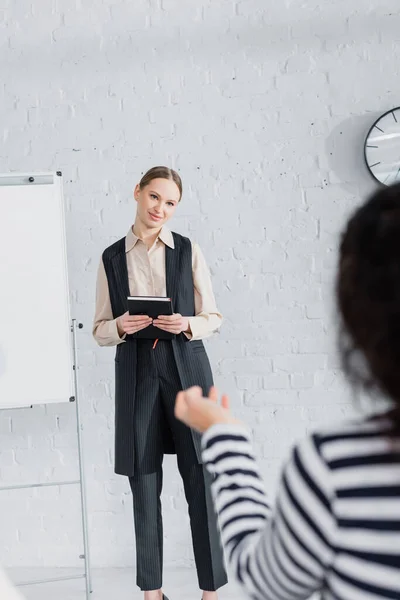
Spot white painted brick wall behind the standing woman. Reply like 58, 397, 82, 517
0, 0, 400, 566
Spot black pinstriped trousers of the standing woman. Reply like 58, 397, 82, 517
129, 340, 227, 591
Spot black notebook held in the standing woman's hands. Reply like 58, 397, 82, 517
128, 296, 175, 340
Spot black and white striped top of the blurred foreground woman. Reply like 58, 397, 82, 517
203, 419, 400, 600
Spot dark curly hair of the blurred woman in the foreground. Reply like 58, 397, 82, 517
336, 184, 400, 418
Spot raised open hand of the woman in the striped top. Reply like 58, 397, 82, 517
175, 386, 240, 433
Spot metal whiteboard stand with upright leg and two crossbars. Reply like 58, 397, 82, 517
0, 319, 92, 600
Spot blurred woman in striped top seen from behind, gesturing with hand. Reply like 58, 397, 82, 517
175, 185, 400, 600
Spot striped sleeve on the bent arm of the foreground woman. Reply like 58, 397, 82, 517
203, 424, 335, 600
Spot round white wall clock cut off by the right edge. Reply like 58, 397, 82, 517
365, 107, 400, 185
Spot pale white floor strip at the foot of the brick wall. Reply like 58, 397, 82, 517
7, 569, 244, 600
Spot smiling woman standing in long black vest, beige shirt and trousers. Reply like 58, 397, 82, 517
93, 167, 226, 600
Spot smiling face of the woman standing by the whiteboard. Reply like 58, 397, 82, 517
134, 178, 180, 229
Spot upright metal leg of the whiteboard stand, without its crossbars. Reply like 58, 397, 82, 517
71, 319, 92, 600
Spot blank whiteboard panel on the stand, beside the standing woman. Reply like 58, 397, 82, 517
0, 173, 74, 409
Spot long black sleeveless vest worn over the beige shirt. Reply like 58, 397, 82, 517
103, 233, 213, 476
